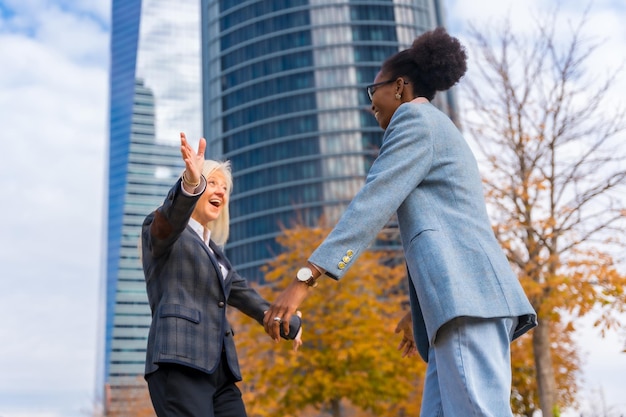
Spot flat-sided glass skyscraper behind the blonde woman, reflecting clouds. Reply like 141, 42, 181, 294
98, 0, 202, 406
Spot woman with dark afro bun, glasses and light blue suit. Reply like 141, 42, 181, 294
264, 28, 537, 417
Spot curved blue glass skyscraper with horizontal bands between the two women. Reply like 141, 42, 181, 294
202, 0, 446, 280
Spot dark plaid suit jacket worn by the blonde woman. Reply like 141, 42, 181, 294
142, 180, 300, 380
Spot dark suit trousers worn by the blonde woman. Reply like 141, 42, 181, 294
146, 355, 247, 417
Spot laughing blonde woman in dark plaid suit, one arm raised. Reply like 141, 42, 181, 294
141, 133, 302, 417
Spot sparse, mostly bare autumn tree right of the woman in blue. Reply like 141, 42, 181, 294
461, 9, 626, 417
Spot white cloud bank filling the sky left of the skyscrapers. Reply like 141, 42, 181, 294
0, 0, 108, 417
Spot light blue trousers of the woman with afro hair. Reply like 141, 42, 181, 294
420, 317, 517, 417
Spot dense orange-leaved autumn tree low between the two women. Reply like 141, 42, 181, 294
232, 226, 425, 417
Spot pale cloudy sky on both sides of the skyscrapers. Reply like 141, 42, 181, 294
0, 0, 626, 417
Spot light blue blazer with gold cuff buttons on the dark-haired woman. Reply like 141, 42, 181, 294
309, 103, 537, 360
